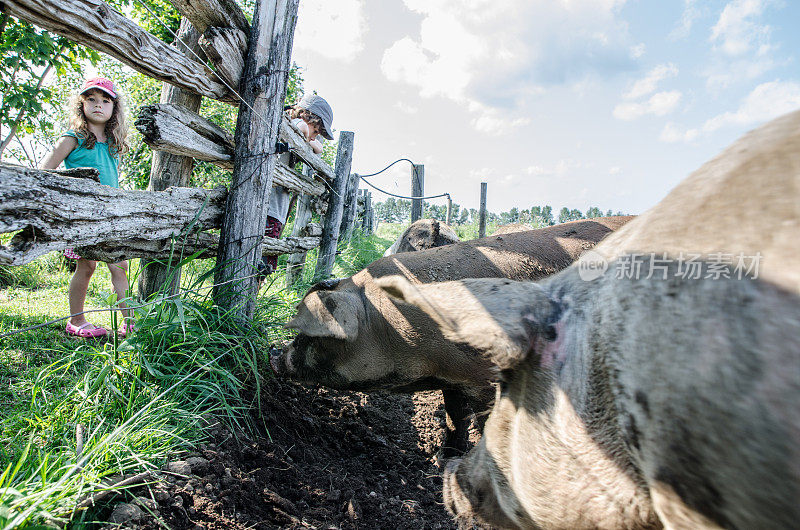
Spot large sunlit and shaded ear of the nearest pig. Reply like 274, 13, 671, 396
375, 276, 557, 370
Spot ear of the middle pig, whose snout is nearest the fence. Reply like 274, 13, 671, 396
286, 291, 359, 340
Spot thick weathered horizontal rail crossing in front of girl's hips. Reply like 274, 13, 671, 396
0, 164, 227, 265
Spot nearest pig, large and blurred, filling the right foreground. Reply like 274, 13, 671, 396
376, 111, 800, 529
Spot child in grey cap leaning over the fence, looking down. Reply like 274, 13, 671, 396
259, 94, 333, 279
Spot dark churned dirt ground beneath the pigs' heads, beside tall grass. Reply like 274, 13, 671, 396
96, 380, 478, 530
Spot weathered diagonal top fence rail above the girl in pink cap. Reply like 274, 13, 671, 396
2, 0, 233, 101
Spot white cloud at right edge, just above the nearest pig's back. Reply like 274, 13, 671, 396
703, 81, 800, 132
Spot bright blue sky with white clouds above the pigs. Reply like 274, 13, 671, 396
292, 0, 800, 214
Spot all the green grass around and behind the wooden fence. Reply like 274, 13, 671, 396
0, 224, 412, 528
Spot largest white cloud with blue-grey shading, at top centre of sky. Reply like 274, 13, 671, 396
381, 0, 643, 132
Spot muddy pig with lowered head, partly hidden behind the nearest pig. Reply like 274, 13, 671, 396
270, 216, 631, 458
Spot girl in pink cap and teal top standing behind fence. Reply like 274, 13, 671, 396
41, 77, 133, 338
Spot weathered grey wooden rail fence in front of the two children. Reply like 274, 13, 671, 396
0, 0, 358, 314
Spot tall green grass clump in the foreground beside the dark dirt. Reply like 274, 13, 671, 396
0, 254, 291, 528
